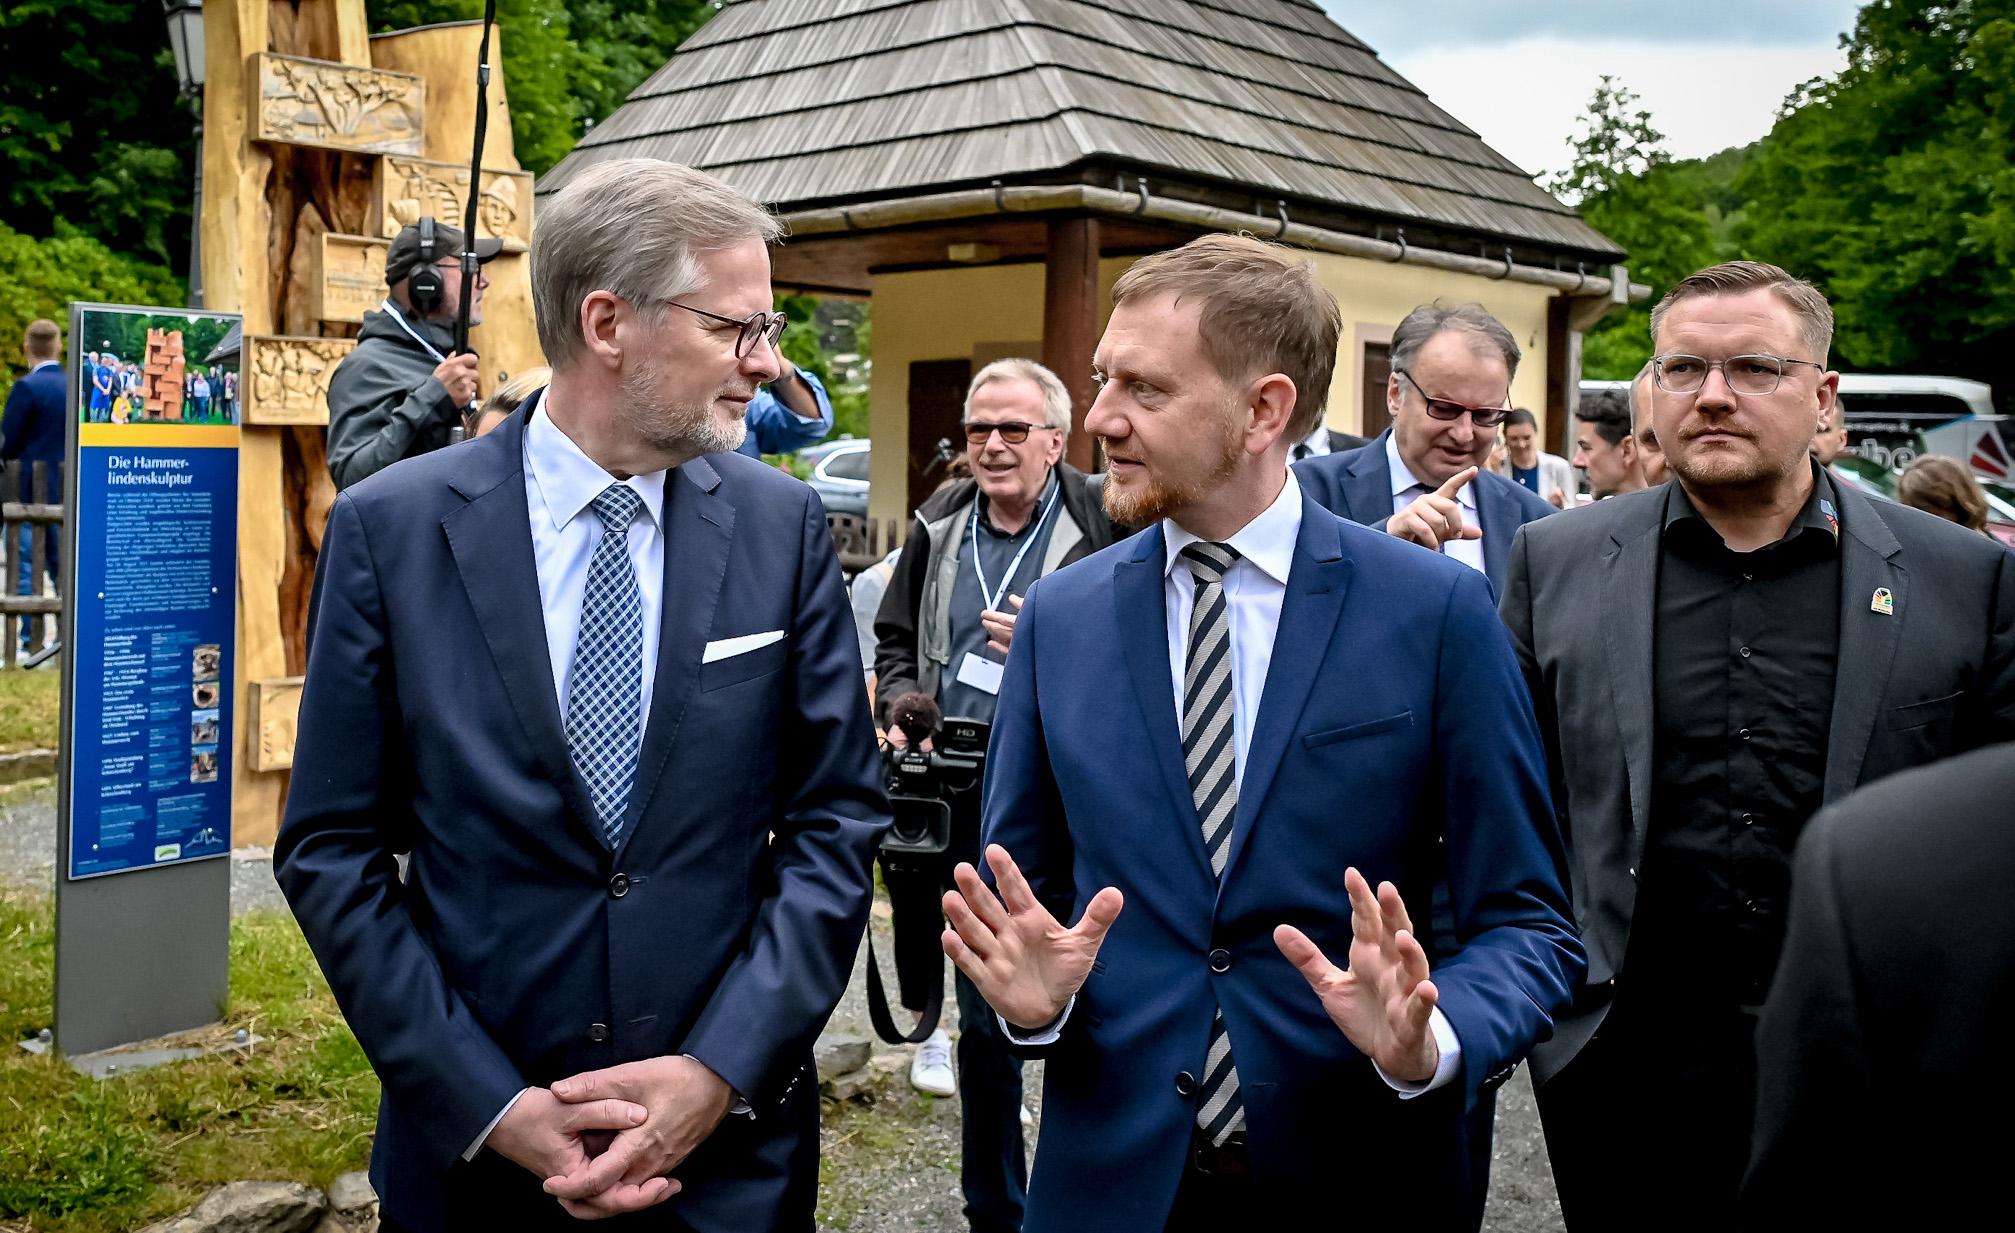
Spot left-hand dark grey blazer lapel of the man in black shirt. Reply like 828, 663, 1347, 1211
1600, 502, 1664, 860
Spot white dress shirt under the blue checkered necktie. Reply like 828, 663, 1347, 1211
461, 404, 665, 1160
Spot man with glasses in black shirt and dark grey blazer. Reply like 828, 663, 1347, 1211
1501, 262, 2015, 1229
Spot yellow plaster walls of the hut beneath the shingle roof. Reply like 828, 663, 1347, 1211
868, 252, 1552, 522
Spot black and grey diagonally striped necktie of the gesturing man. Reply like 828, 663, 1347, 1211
1181, 542, 1245, 1144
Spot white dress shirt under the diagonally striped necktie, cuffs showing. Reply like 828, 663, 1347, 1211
1001, 471, 1481, 1098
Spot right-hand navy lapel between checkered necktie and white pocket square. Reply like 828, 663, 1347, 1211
619, 457, 735, 852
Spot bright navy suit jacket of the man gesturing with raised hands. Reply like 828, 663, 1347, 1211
985, 495, 1582, 1233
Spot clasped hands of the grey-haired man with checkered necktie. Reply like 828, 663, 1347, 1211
486, 1058, 733, 1221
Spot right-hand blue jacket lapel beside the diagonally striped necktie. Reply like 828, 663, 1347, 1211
1217, 505, 1346, 893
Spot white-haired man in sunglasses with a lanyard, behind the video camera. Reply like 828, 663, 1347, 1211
875, 359, 1118, 1233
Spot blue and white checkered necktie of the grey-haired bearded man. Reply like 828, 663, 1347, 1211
566, 484, 643, 848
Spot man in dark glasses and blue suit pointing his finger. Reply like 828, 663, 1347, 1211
1294, 304, 1556, 594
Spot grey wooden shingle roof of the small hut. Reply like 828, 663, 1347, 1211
538, 0, 1618, 260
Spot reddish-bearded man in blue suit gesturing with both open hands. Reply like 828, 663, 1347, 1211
945, 236, 1582, 1233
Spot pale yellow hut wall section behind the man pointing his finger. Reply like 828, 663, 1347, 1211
1305, 252, 1554, 439
